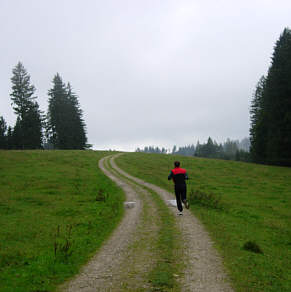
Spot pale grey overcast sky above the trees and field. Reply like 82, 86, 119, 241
0, 0, 291, 150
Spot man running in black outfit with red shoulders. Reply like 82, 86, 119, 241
168, 161, 189, 215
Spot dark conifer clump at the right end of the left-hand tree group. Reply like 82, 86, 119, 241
47, 74, 87, 149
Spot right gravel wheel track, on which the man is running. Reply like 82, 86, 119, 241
111, 154, 233, 292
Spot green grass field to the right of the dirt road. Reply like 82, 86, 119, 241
117, 153, 291, 292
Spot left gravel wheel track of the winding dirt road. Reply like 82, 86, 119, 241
61, 157, 142, 292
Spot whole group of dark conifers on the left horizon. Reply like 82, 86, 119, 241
0, 62, 90, 150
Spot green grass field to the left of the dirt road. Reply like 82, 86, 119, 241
0, 151, 124, 292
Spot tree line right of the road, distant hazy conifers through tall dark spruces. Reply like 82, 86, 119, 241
138, 28, 291, 166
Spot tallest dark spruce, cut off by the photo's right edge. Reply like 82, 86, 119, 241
263, 28, 291, 165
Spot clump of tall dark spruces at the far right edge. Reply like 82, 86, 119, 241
250, 28, 291, 166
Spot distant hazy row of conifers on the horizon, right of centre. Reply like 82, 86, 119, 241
136, 137, 250, 162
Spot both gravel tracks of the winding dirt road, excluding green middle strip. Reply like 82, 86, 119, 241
61, 154, 233, 292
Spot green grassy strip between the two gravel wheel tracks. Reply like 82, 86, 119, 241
107, 157, 183, 291
